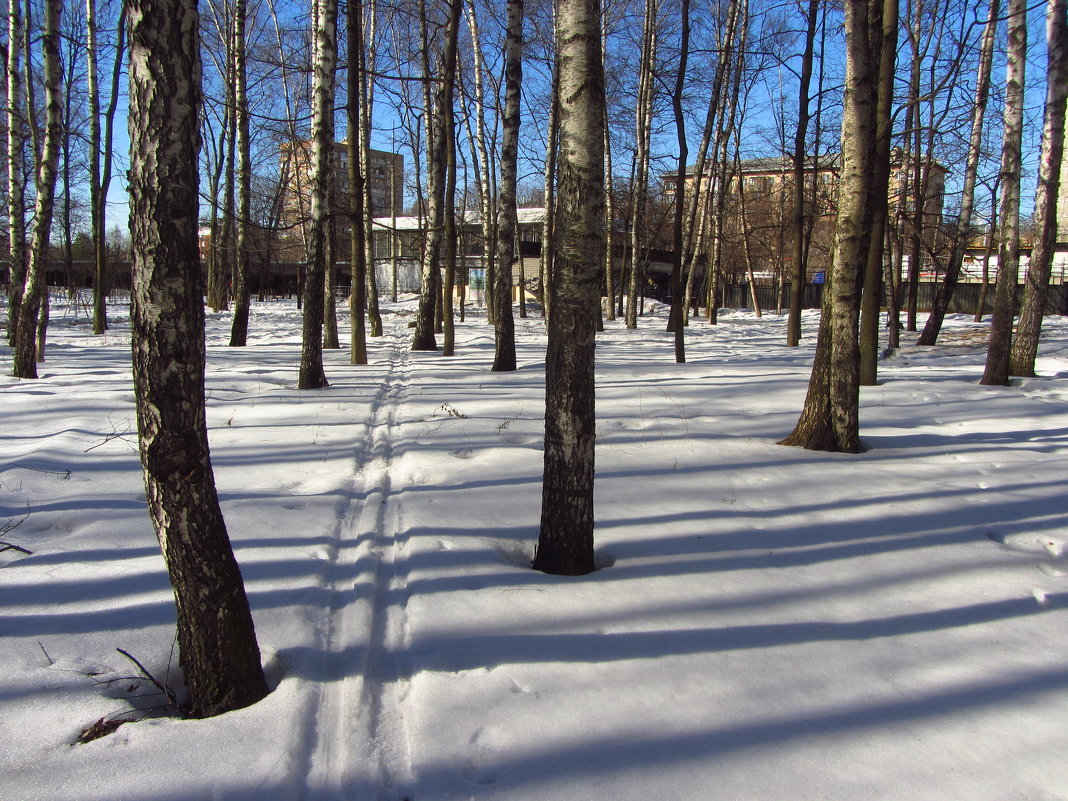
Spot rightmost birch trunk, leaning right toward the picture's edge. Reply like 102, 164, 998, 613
1009, 0, 1068, 376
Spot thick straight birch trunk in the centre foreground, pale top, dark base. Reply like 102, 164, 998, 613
534, 0, 604, 576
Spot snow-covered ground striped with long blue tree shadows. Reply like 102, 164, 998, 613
0, 301, 1068, 801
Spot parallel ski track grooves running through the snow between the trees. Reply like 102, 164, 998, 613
303, 328, 412, 801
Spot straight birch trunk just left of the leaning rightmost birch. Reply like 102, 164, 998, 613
979, 0, 1027, 387
